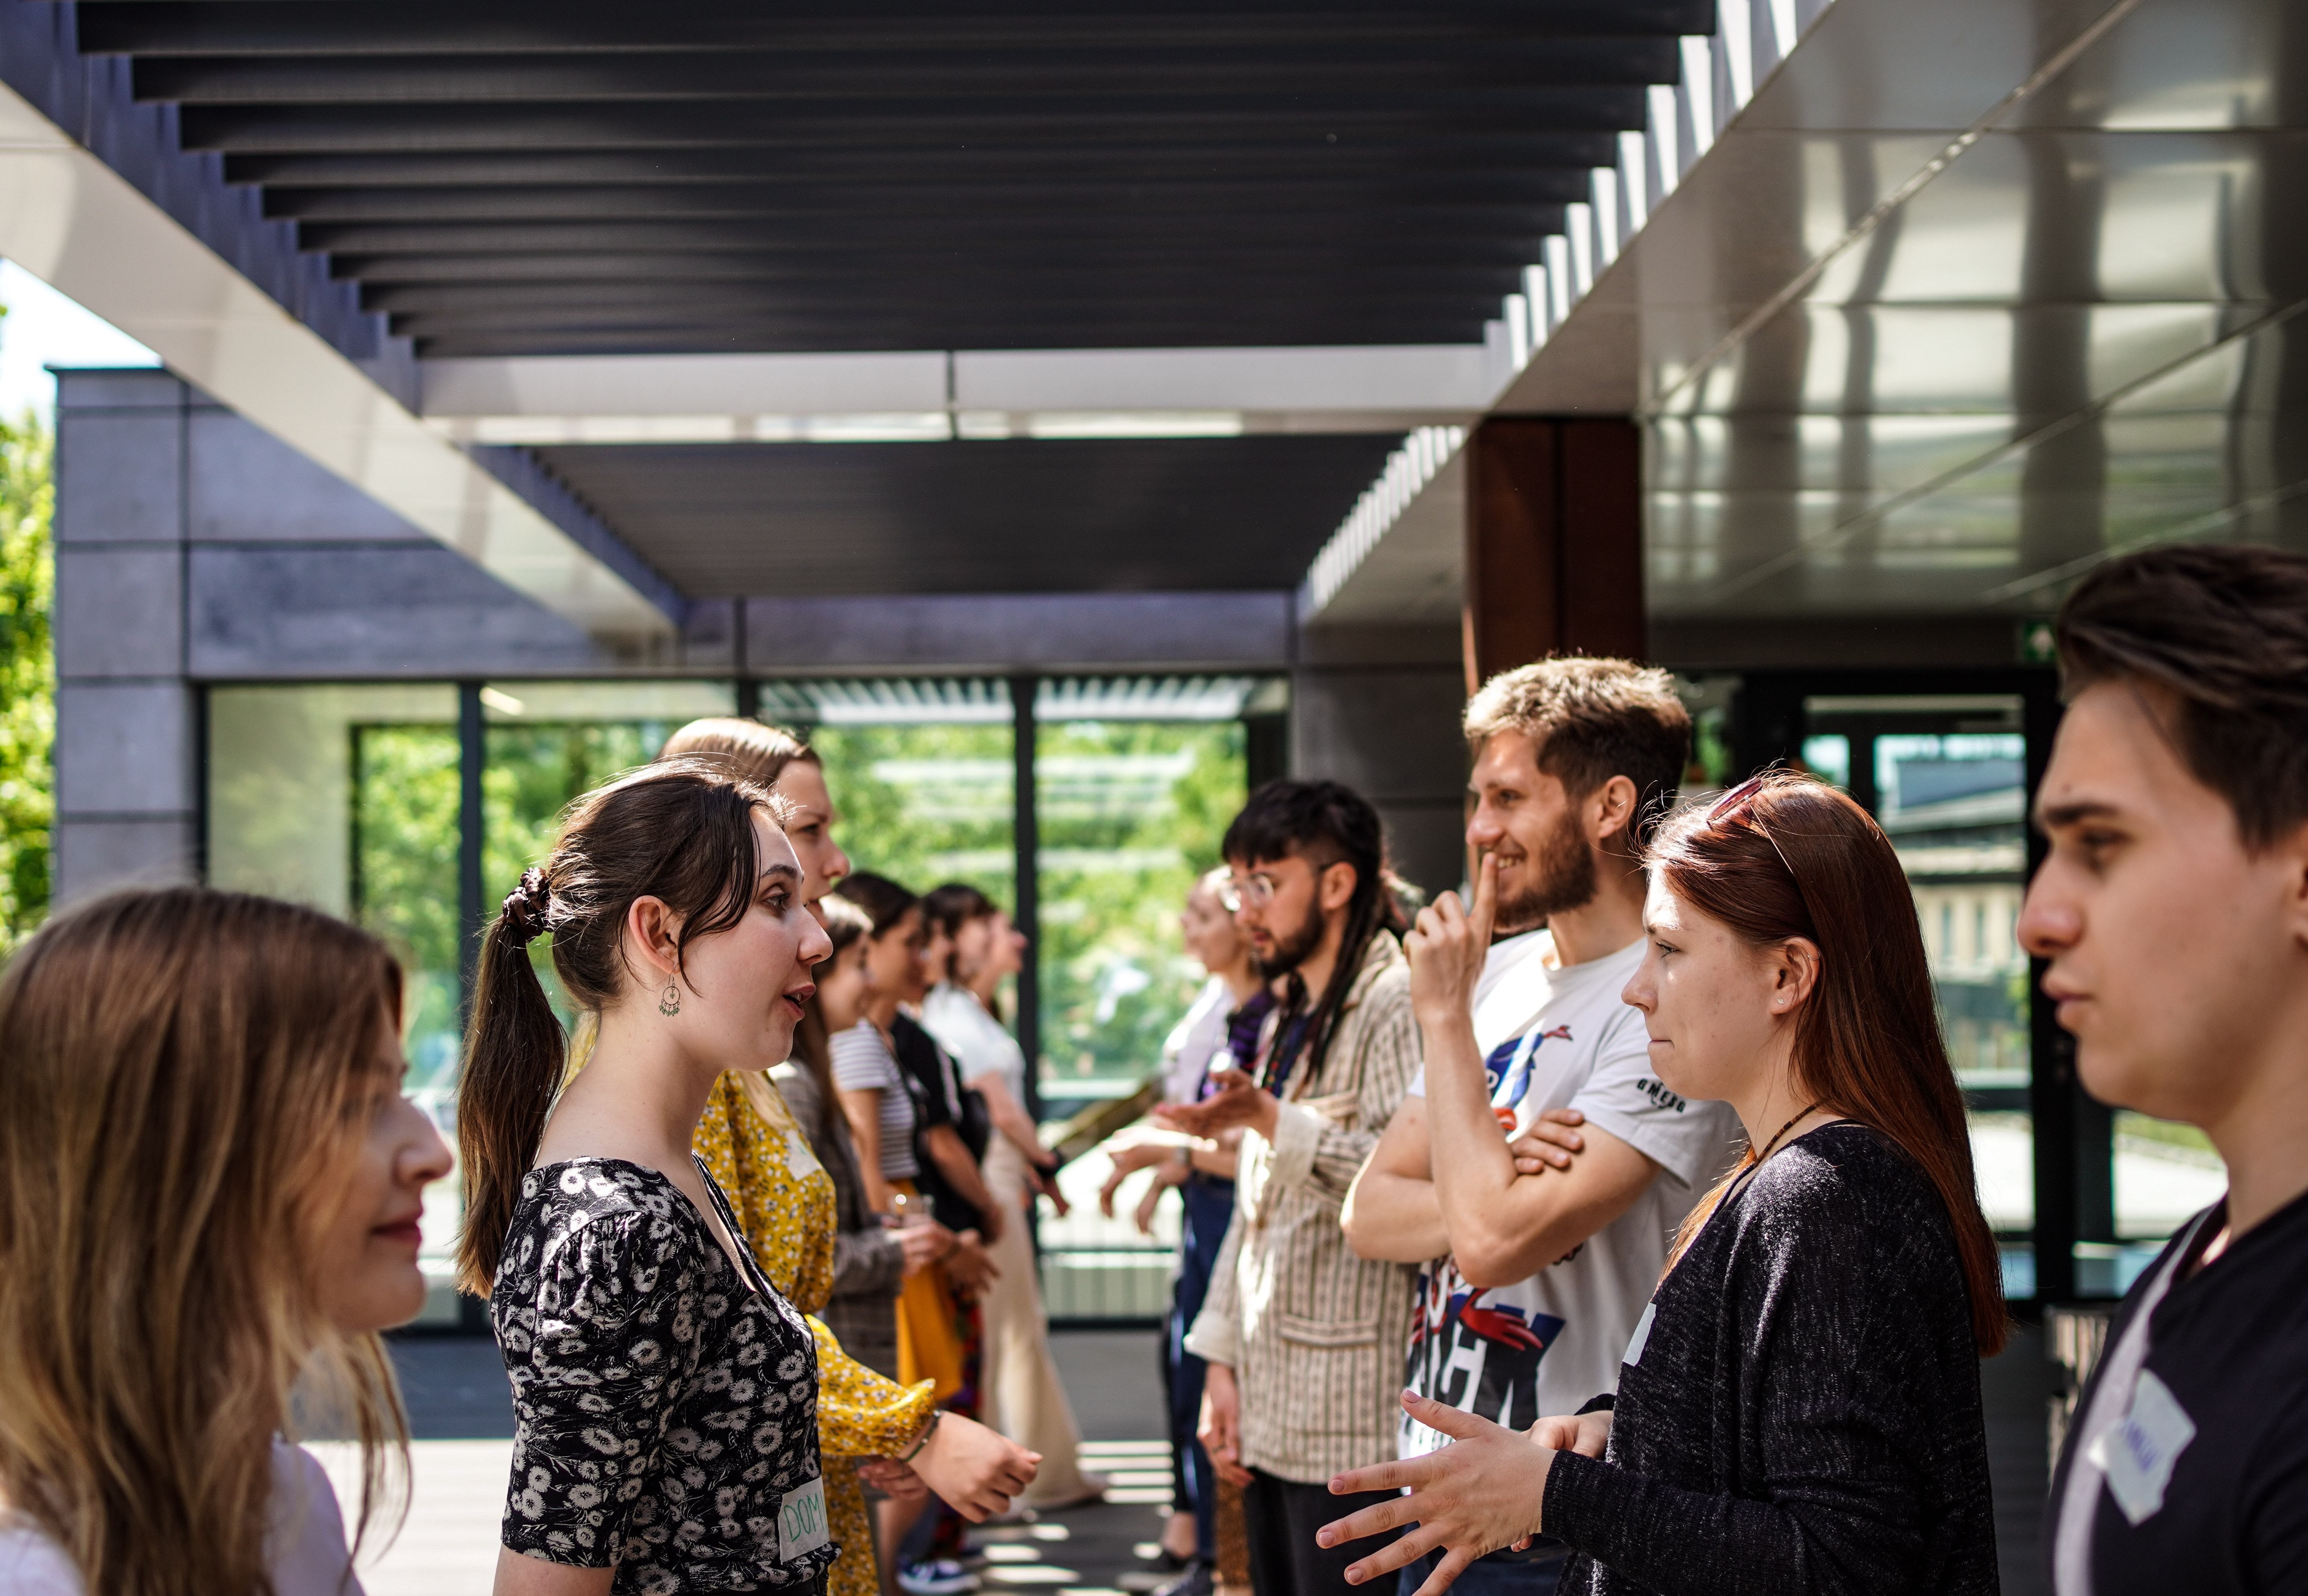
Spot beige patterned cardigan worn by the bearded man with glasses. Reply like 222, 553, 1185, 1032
1186, 932, 1419, 1483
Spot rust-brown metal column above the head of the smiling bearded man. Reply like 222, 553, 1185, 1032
1463, 415, 1646, 692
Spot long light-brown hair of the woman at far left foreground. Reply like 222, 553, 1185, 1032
0, 888, 408, 1596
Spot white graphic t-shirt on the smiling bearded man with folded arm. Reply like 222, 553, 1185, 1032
1401, 932, 1740, 1458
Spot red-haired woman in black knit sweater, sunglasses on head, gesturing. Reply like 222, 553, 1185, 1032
1320, 773, 2006, 1596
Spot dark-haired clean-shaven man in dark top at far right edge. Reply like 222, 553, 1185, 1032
2020, 547, 2308, 1596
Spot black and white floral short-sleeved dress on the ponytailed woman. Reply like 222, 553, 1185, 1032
489, 1158, 840, 1596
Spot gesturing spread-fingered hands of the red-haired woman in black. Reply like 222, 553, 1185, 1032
1315, 1391, 1556, 1596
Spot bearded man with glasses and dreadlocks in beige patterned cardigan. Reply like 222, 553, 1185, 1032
1163, 782, 1419, 1596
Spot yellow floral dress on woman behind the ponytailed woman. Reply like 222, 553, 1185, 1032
697, 1075, 937, 1596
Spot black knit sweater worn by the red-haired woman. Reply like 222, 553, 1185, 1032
1542, 1123, 1996, 1596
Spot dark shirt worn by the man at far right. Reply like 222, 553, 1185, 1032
2042, 1197, 2308, 1596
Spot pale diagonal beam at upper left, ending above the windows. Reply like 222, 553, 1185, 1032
0, 85, 674, 648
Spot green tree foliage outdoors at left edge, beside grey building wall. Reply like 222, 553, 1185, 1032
0, 418, 55, 946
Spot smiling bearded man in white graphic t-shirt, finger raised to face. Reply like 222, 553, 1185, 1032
1346, 657, 1738, 1596
